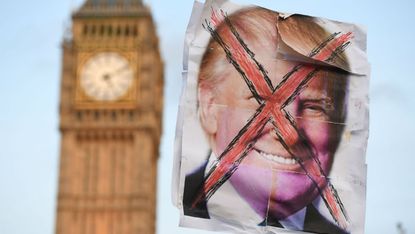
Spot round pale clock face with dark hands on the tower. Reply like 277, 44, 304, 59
80, 52, 134, 101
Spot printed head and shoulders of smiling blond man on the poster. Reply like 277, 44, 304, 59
183, 7, 348, 233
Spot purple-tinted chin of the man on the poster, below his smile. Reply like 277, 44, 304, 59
230, 166, 324, 220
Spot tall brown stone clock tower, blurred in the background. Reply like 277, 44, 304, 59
56, 0, 163, 234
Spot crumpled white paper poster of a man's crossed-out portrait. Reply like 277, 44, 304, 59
172, 0, 370, 233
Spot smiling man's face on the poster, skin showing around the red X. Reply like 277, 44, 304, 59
201, 51, 346, 219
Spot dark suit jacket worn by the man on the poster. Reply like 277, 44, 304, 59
183, 161, 347, 234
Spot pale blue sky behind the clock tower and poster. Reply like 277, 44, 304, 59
0, 0, 415, 234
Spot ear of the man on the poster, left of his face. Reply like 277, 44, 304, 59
198, 87, 218, 135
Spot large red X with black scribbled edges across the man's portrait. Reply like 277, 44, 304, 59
193, 10, 351, 228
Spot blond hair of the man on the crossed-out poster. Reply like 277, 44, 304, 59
198, 7, 348, 122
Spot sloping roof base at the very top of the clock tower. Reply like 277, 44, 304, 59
73, 0, 148, 18
